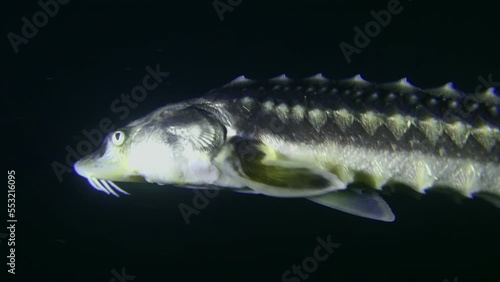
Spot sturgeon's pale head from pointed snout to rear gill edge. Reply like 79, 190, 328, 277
74, 104, 226, 195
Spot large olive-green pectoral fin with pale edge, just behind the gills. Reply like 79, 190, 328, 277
216, 137, 346, 197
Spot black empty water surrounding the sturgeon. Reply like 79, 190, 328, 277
0, 0, 500, 282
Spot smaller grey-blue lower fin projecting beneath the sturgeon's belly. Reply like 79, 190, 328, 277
308, 189, 396, 222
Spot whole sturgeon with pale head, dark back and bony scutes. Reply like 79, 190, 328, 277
74, 74, 500, 222
